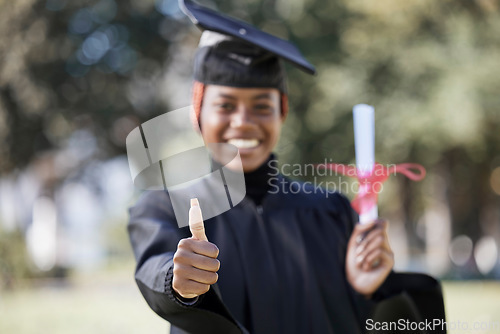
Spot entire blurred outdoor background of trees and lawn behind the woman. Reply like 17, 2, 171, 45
0, 0, 500, 334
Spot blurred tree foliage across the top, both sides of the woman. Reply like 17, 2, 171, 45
0, 0, 500, 276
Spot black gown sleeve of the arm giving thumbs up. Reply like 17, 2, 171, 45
128, 191, 245, 334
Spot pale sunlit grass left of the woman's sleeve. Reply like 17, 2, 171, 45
0, 266, 169, 334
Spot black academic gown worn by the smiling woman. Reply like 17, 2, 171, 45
128, 176, 446, 334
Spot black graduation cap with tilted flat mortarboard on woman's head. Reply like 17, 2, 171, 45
179, 0, 316, 93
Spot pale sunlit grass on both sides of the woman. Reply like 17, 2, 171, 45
0, 265, 500, 334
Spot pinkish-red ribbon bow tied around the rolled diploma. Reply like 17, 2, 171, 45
317, 163, 426, 214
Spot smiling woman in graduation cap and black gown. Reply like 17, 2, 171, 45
129, 1, 446, 334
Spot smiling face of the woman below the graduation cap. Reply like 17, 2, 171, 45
200, 85, 284, 172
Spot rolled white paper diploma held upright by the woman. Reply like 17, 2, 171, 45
352, 104, 378, 224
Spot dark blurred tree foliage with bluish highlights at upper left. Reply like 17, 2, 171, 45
0, 0, 183, 172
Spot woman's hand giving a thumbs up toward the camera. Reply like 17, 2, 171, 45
172, 198, 220, 298
